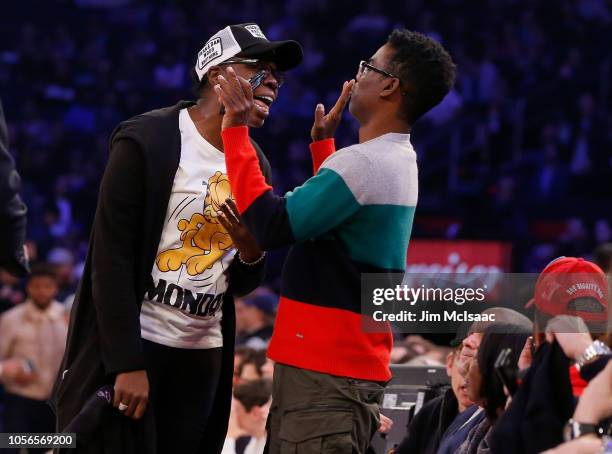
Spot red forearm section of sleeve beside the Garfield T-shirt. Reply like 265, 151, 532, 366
221, 126, 272, 214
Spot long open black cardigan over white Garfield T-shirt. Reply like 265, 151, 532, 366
50, 101, 270, 454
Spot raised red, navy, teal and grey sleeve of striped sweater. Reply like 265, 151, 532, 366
221, 126, 368, 250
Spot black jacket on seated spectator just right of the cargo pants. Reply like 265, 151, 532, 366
395, 388, 459, 454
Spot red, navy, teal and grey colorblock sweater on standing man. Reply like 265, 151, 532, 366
222, 126, 418, 381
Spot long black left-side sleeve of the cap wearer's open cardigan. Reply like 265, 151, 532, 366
92, 140, 145, 374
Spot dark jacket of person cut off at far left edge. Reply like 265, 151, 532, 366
0, 97, 28, 276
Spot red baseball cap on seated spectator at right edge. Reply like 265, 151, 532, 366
525, 257, 608, 323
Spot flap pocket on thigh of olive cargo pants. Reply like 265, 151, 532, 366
279, 406, 353, 454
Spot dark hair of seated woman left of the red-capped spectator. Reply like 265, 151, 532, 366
478, 324, 531, 422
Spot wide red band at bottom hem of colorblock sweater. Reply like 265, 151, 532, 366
268, 296, 393, 381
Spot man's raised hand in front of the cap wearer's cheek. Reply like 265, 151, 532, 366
214, 66, 263, 129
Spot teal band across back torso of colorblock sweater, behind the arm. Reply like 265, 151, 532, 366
337, 205, 416, 270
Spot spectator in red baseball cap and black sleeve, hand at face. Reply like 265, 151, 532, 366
490, 257, 610, 454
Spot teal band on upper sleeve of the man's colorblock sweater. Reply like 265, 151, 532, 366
285, 169, 360, 241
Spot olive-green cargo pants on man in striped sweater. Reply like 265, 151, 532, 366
265, 364, 384, 454
